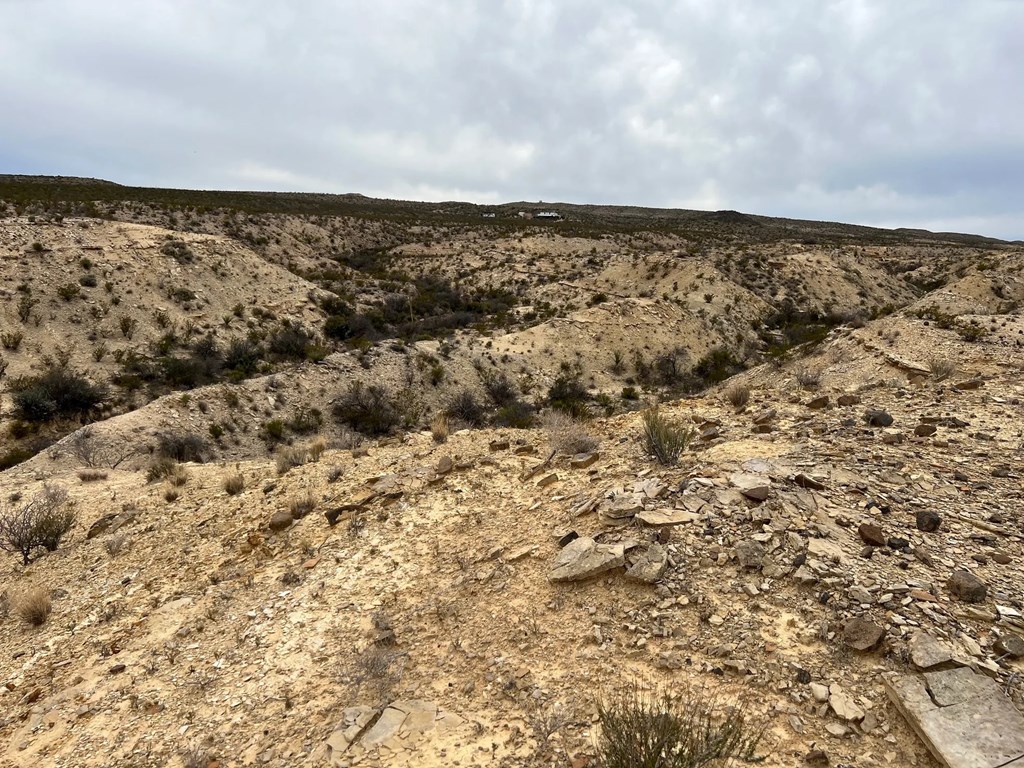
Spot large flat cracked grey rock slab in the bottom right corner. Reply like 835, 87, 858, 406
886, 668, 1024, 768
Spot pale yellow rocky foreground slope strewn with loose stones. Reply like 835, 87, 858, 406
0, 309, 1024, 766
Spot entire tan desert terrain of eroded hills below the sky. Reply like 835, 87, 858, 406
0, 179, 1024, 768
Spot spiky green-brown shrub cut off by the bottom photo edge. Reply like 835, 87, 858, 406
597, 685, 764, 768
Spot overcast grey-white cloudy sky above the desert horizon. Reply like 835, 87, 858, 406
0, 0, 1024, 239
